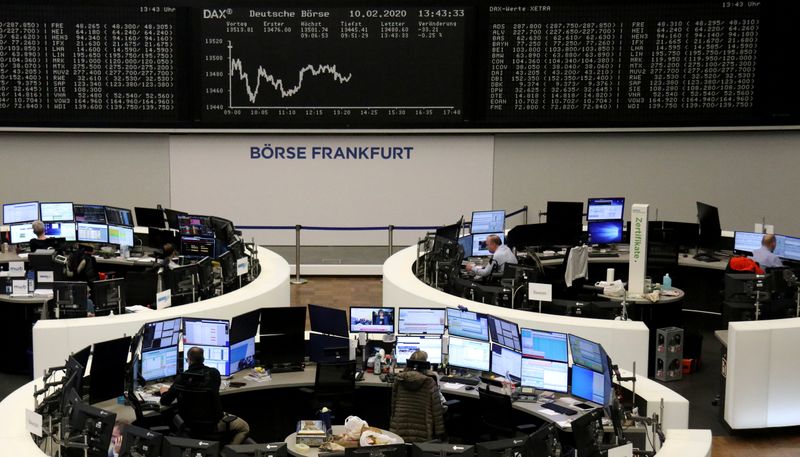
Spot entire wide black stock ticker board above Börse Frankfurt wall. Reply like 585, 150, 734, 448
0, 0, 800, 129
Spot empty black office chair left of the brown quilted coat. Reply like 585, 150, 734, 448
300, 360, 356, 418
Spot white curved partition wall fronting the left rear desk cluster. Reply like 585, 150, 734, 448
33, 248, 289, 373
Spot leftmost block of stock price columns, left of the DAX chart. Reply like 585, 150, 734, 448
0, 5, 179, 125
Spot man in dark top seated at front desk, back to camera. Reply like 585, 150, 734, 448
161, 346, 250, 444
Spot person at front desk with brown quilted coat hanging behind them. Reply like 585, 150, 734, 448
389, 351, 444, 443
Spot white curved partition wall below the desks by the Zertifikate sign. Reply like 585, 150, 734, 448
383, 246, 649, 375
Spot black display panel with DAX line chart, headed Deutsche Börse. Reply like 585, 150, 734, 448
200, 7, 470, 126
